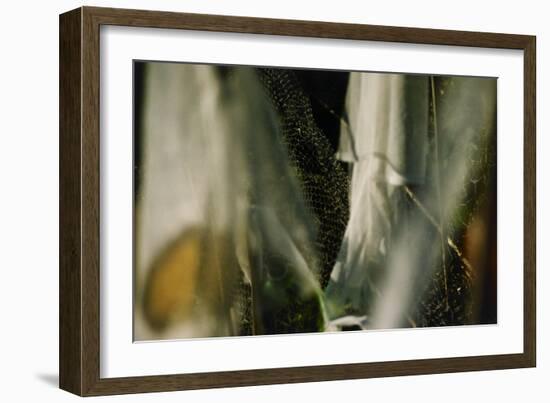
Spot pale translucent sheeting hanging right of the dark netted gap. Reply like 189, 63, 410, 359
326, 73, 496, 329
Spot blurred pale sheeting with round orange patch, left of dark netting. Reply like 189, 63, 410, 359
134, 63, 324, 340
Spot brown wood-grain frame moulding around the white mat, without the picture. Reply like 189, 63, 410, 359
59, 7, 536, 396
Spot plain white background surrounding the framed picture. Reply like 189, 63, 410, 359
0, 0, 550, 403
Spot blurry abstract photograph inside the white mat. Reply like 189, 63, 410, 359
133, 60, 497, 341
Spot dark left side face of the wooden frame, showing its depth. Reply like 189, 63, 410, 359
59, 10, 82, 394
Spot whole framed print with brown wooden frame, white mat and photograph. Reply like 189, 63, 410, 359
60, 7, 536, 396
